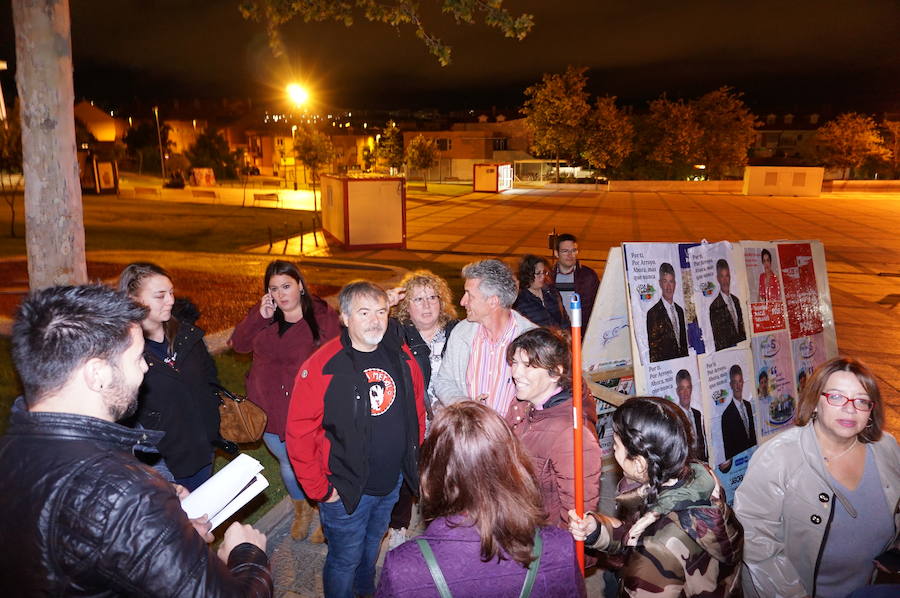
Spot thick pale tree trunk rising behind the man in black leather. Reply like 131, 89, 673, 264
12, 0, 87, 289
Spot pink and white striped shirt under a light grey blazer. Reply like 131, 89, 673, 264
466, 314, 517, 416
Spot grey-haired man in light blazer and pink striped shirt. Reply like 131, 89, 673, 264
434, 260, 535, 416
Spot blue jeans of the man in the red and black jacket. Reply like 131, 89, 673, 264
319, 476, 403, 598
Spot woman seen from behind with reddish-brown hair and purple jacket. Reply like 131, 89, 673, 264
375, 401, 585, 598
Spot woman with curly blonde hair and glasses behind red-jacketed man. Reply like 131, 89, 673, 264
388, 270, 459, 548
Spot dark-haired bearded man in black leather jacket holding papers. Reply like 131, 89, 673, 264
0, 285, 273, 597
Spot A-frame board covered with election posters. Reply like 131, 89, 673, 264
583, 240, 837, 502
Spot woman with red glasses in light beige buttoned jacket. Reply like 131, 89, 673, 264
734, 358, 900, 598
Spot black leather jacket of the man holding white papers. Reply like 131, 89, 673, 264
0, 399, 273, 597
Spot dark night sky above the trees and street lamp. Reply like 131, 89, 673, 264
0, 0, 900, 112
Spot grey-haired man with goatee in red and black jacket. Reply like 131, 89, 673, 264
285, 281, 425, 598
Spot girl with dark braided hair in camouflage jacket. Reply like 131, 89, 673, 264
569, 397, 744, 598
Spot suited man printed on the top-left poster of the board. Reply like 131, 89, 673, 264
647, 262, 688, 362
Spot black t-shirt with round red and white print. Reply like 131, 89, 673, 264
354, 347, 406, 496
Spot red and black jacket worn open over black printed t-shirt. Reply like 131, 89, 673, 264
285, 329, 425, 514
